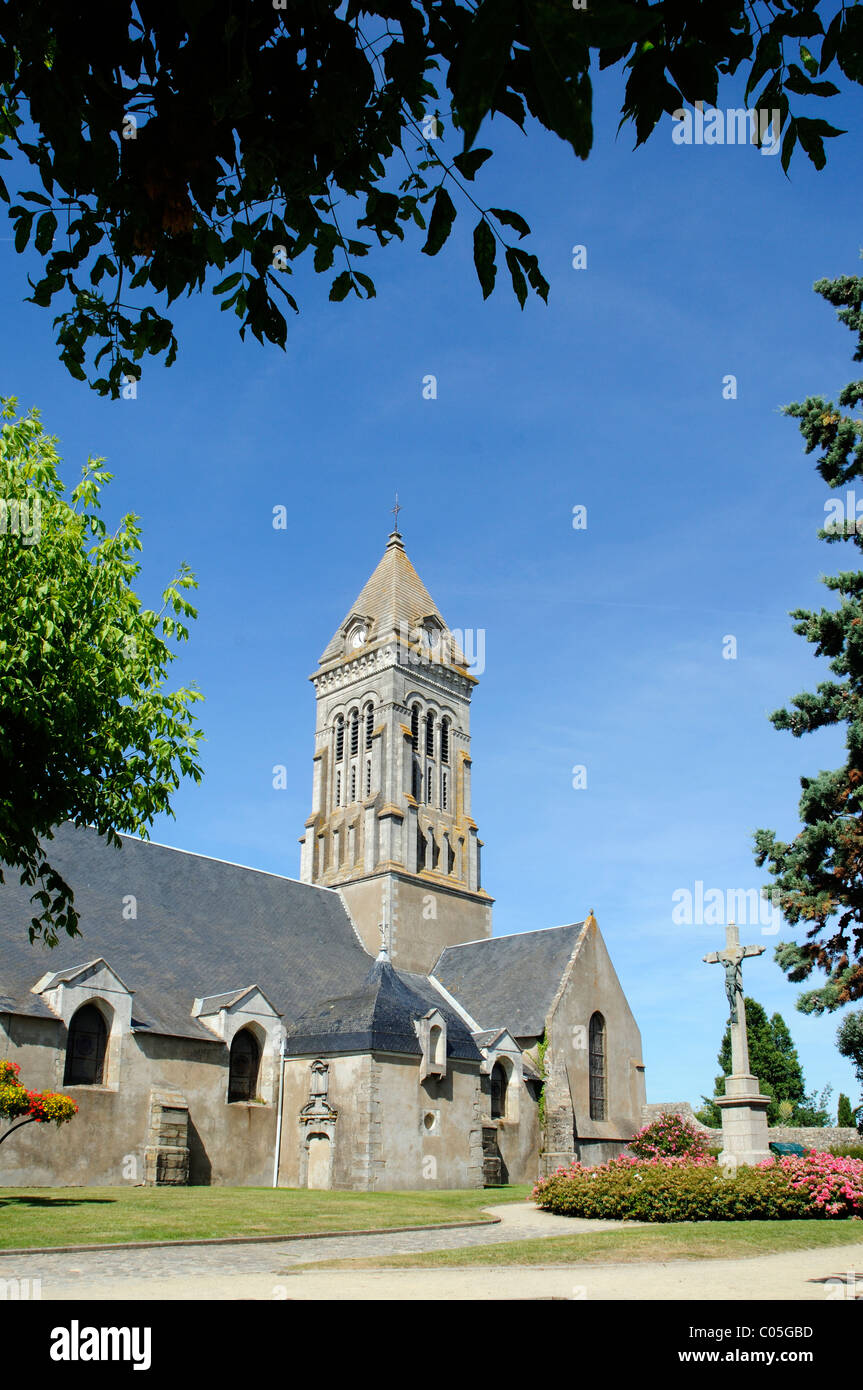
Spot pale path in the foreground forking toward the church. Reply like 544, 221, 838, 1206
0, 1202, 863, 1302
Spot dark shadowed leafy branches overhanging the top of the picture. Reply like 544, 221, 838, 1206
0, 0, 863, 395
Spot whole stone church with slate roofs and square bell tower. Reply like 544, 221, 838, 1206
0, 530, 645, 1191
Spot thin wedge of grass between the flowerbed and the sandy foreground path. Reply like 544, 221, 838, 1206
292, 1220, 863, 1273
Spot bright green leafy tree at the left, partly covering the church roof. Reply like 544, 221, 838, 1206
0, 400, 203, 945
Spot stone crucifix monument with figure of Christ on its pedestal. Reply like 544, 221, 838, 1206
703, 922, 770, 1166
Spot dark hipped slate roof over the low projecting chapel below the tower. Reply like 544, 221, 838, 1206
286, 958, 482, 1062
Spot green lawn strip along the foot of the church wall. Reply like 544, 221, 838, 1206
0, 1183, 531, 1250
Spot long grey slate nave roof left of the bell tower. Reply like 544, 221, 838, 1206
0, 826, 377, 1043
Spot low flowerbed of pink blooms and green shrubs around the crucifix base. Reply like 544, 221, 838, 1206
532, 1152, 863, 1222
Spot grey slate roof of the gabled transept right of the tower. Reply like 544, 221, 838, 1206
431, 922, 584, 1038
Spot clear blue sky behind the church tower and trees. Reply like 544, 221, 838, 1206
0, 65, 863, 1108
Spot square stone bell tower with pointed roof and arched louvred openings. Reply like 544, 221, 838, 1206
300, 525, 493, 973
